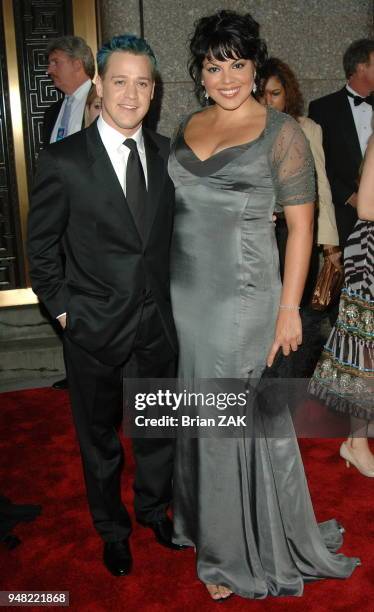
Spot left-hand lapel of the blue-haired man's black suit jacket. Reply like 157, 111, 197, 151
85, 121, 141, 240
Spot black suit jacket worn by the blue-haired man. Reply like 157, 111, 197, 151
28, 122, 177, 365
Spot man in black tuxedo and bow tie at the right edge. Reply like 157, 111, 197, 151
309, 39, 374, 249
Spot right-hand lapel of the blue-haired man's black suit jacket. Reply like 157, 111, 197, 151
143, 128, 165, 243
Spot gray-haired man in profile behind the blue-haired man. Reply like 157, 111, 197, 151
43, 36, 95, 145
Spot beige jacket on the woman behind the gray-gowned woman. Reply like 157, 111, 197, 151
298, 117, 339, 245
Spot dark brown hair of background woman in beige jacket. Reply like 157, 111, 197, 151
257, 57, 304, 119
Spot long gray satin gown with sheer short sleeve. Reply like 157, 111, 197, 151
169, 109, 359, 598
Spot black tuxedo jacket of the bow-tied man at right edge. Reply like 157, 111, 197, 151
309, 87, 362, 247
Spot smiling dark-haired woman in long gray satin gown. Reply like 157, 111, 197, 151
169, 11, 358, 600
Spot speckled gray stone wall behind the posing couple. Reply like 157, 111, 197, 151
101, 0, 374, 135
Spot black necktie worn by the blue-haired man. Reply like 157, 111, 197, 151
123, 138, 147, 238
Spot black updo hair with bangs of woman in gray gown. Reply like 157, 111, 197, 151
188, 11, 267, 103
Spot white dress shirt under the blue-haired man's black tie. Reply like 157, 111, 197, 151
97, 115, 148, 195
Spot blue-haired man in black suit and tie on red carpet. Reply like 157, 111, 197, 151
29, 35, 177, 576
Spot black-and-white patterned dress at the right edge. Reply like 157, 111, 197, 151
310, 220, 374, 421
